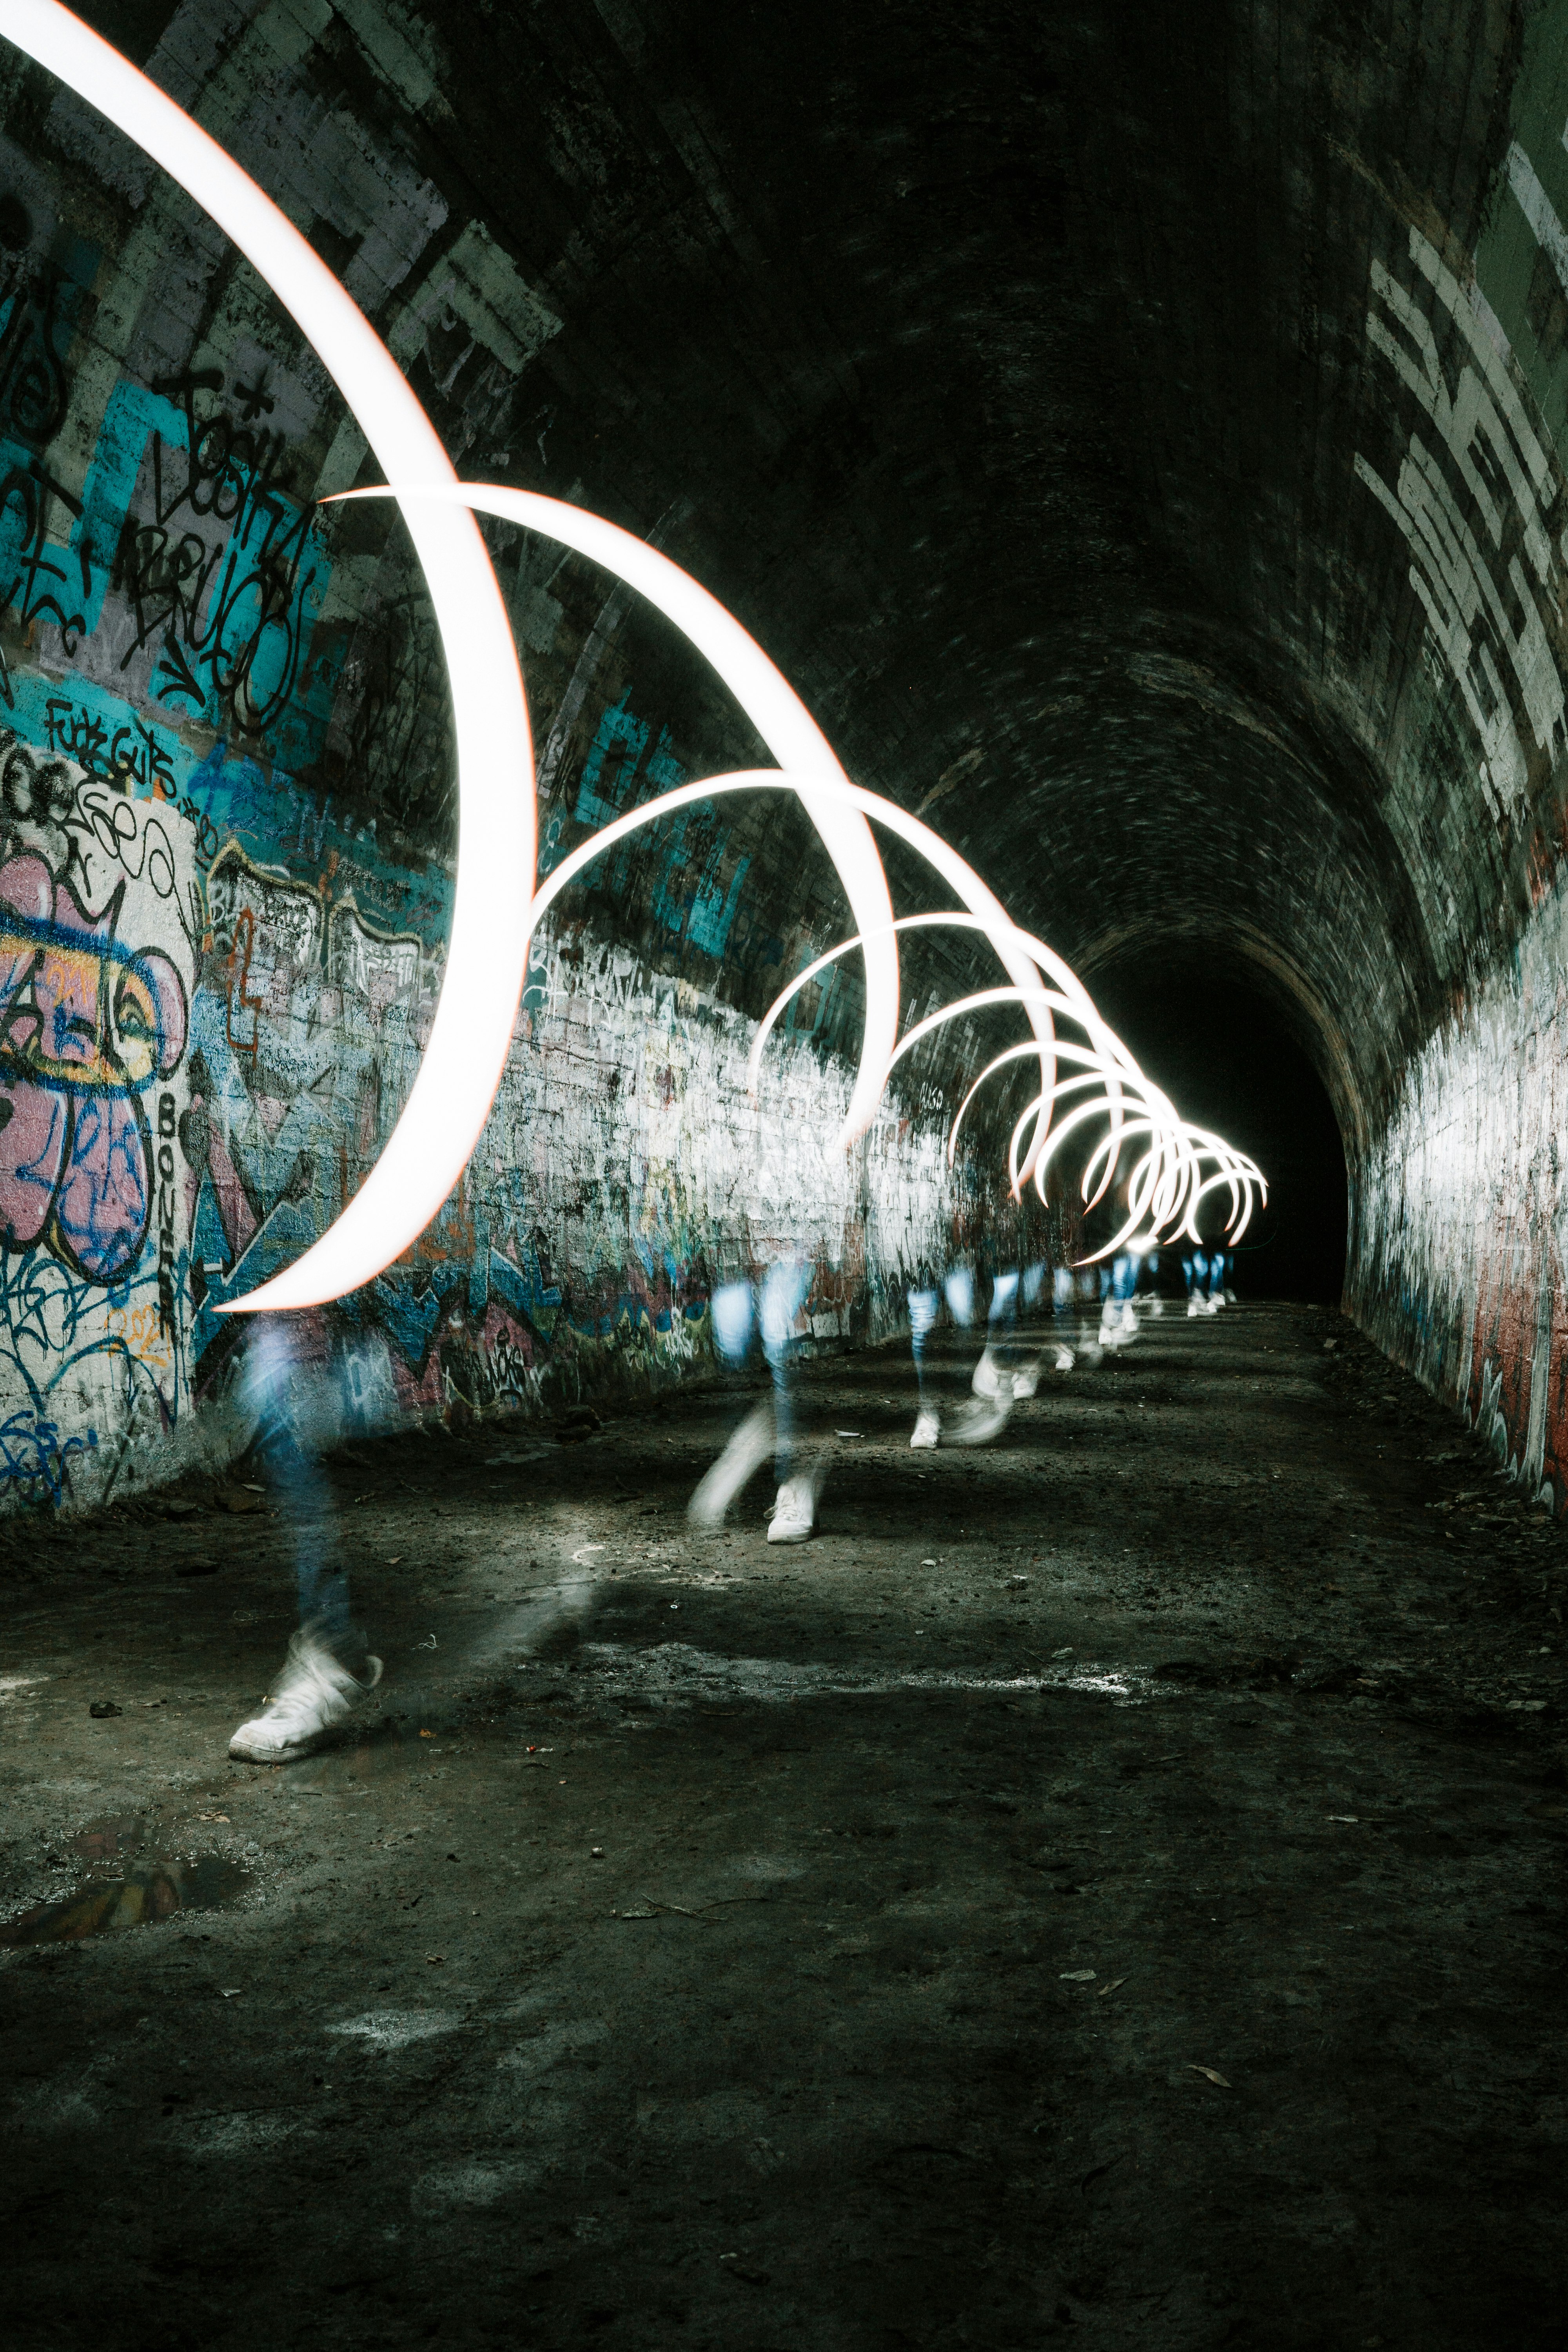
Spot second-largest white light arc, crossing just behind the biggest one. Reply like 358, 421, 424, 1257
332, 485, 898, 1145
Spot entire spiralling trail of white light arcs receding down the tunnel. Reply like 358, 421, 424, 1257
0, 0, 1262, 1312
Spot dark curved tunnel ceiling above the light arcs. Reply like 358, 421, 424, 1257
89, 0, 1568, 1134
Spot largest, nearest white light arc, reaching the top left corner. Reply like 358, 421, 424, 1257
0, 0, 536, 1315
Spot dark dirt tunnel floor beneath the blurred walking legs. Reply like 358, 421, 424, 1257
0, 1305, 1568, 2352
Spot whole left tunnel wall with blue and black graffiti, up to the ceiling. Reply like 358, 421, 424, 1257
0, 5, 962, 1508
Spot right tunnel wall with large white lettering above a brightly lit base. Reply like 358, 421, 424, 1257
1347, 9, 1568, 1510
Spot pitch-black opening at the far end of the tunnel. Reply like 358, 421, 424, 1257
1096, 950, 1347, 1303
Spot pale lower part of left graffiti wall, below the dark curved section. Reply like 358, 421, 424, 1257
0, 663, 964, 1503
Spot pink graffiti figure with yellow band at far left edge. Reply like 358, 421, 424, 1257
0, 854, 186, 1282
